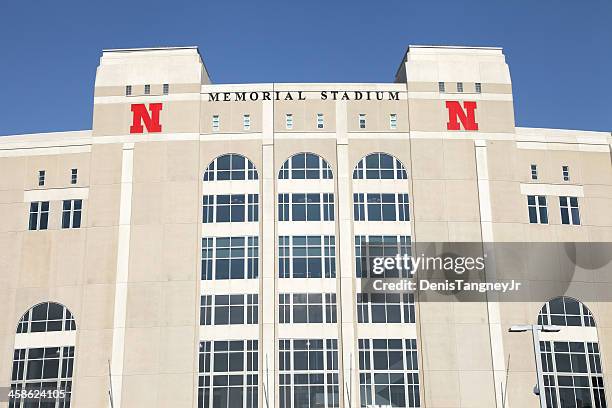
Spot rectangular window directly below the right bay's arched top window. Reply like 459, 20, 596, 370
353, 193, 410, 221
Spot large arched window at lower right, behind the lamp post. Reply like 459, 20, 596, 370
538, 296, 607, 408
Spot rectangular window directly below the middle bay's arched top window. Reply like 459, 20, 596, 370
278, 193, 334, 221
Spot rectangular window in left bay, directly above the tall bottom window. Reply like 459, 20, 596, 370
200, 293, 259, 326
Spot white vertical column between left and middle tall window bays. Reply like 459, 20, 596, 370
259, 95, 277, 408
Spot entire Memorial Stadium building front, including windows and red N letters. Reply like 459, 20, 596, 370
0, 46, 612, 408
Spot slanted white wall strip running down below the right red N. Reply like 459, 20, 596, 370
474, 140, 510, 408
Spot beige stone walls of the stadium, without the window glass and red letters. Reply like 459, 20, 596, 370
0, 46, 612, 408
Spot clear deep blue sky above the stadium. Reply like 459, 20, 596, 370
0, 0, 612, 135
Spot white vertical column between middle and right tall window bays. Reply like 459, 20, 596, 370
336, 101, 359, 408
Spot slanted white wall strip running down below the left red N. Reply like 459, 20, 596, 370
109, 143, 134, 408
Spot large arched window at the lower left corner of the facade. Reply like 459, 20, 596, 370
9, 302, 76, 408
